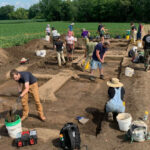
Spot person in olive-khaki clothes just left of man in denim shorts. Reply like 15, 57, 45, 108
82, 38, 97, 71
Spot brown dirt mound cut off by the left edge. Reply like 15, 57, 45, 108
0, 48, 9, 66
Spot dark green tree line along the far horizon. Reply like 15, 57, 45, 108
0, 0, 150, 22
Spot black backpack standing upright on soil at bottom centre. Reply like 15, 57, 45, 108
60, 123, 81, 150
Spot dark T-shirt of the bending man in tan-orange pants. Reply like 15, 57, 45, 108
18, 72, 37, 85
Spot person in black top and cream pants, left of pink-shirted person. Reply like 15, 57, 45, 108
55, 37, 66, 67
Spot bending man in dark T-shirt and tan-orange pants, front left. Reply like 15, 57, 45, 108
10, 69, 46, 121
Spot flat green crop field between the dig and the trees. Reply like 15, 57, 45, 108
0, 20, 134, 48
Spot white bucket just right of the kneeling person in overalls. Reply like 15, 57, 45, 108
117, 113, 132, 131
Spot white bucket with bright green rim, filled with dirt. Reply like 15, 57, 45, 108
5, 116, 22, 139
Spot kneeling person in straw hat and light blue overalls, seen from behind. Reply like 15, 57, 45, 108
105, 78, 125, 120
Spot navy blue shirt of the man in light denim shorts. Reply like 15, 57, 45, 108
92, 43, 107, 61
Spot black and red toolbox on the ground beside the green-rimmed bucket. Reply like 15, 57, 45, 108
14, 130, 38, 147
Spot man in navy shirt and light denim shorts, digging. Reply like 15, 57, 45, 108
90, 41, 110, 80
